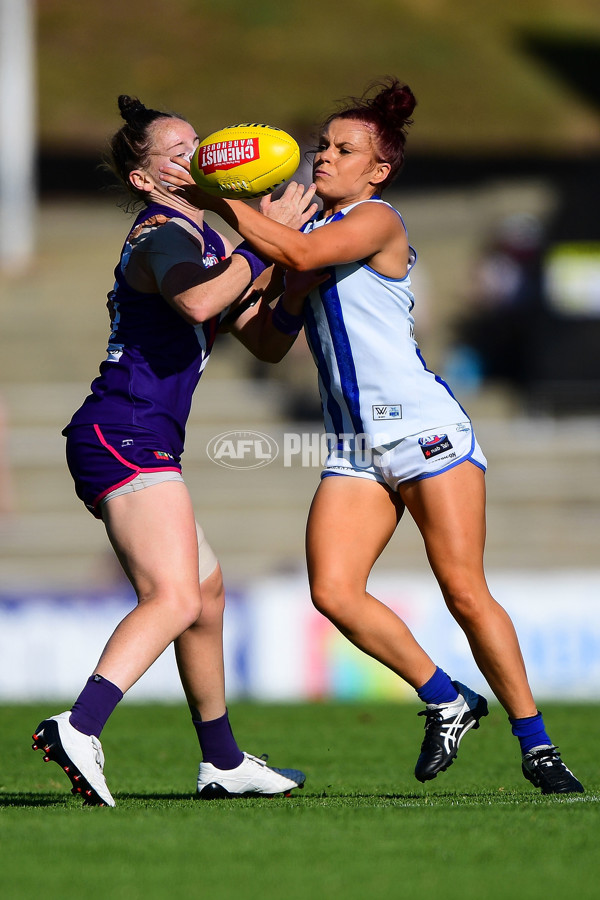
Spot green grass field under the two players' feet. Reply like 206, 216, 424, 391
0, 703, 600, 900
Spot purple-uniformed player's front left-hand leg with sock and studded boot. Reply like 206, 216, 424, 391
33, 482, 202, 806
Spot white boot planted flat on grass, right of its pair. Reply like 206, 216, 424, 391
198, 753, 306, 800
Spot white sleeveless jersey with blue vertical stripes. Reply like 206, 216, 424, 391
302, 199, 468, 447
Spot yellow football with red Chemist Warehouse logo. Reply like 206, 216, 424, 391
190, 124, 300, 200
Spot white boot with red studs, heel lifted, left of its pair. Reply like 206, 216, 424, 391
33, 711, 115, 806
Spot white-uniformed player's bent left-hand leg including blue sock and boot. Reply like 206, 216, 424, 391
307, 476, 487, 781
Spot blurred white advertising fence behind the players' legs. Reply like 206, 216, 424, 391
0, 570, 600, 702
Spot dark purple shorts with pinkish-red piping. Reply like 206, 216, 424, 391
64, 425, 181, 519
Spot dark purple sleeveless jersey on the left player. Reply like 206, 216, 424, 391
63, 204, 226, 456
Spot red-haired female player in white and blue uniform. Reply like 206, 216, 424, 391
162, 78, 583, 793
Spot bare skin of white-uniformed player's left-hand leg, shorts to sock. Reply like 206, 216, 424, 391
306, 476, 436, 688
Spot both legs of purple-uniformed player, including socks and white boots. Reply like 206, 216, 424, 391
34, 482, 305, 806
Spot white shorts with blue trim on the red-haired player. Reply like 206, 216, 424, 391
321, 421, 487, 491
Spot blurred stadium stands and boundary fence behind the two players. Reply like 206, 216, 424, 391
0, 0, 600, 700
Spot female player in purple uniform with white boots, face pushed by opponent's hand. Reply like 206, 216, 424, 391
34, 95, 316, 806
